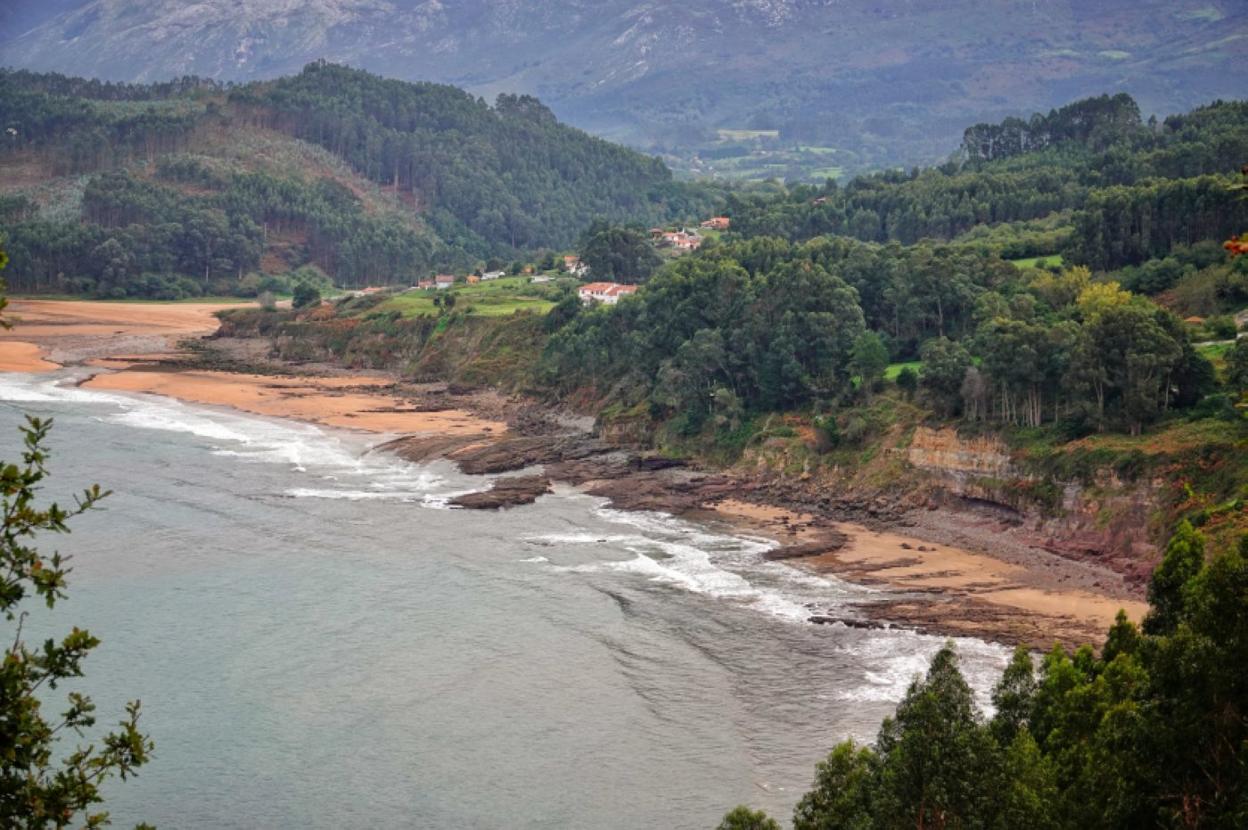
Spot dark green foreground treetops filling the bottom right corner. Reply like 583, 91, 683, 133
720, 523, 1248, 830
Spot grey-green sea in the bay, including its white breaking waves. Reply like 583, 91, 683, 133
0, 373, 1005, 829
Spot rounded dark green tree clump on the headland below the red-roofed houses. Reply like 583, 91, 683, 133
536, 240, 865, 421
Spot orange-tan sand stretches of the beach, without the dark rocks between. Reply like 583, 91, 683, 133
0, 301, 1147, 648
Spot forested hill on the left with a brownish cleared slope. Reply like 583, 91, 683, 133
0, 64, 714, 297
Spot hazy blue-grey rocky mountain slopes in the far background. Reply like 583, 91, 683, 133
0, 0, 1248, 175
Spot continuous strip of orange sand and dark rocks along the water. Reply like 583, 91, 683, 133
0, 300, 1146, 649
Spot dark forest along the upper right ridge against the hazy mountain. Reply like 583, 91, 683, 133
728, 96, 1248, 268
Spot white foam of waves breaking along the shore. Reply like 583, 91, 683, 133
0, 374, 1007, 706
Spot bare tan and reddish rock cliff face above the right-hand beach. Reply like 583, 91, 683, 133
904, 427, 1164, 582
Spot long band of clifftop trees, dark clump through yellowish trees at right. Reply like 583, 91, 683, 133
544, 230, 1223, 433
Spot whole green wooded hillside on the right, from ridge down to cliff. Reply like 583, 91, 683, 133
534, 97, 1248, 549
